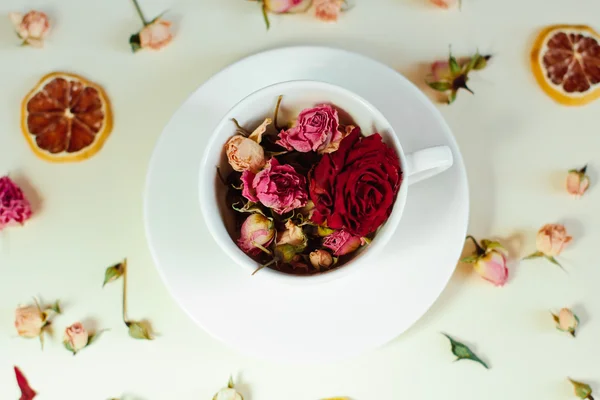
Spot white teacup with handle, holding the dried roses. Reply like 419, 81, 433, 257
199, 80, 453, 283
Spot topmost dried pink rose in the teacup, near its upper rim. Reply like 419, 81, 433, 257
276, 104, 343, 153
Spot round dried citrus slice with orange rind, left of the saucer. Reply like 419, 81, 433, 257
21, 72, 112, 162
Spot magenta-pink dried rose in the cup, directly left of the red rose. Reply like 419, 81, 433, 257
242, 158, 308, 214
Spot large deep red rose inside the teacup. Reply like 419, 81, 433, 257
309, 128, 402, 236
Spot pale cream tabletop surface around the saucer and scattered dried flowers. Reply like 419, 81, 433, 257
0, 0, 600, 400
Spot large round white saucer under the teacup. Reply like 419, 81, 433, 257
145, 47, 469, 362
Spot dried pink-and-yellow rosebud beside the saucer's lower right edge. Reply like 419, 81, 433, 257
461, 235, 508, 286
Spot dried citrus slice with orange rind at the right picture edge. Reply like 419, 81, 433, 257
531, 25, 600, 106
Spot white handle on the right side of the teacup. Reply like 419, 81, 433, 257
405, 146, 454, 185
